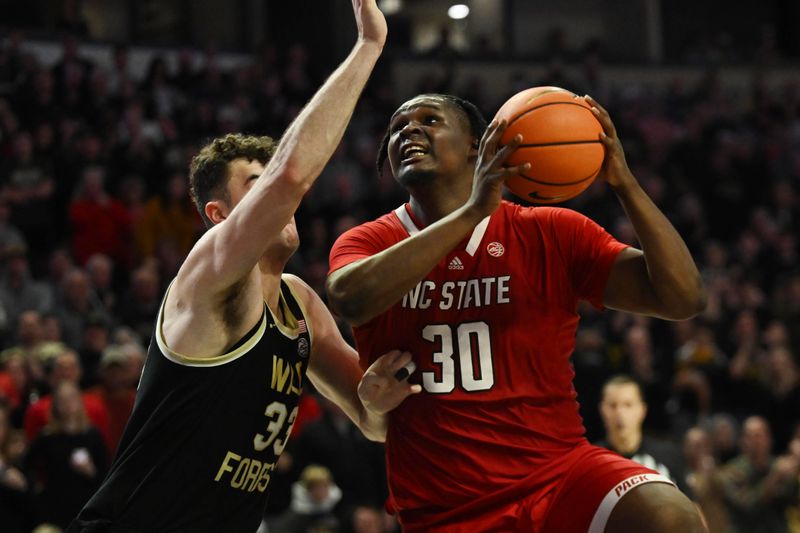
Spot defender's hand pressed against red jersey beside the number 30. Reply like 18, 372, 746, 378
358, 350, 422, 415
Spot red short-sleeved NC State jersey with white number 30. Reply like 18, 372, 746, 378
330, 201, 625, 524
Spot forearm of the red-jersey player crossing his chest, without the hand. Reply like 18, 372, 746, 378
326, 207, 483, 326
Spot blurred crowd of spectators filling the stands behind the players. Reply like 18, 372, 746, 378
0, 20, 800, 533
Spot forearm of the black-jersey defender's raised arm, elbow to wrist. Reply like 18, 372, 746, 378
270, 41, 382, 191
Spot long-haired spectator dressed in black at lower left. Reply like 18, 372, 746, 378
25, 381, 108, 529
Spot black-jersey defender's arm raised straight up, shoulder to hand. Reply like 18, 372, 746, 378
179, 0, 386, 293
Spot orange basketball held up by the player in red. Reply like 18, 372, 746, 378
495, 87, 605, 204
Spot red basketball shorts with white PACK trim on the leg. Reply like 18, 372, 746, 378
403, 444, 672, 533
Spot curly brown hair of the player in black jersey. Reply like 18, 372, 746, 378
189, 133, 278, 228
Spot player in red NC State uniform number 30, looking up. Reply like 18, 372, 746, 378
327, 95, 705, 533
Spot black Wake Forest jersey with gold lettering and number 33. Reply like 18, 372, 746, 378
69, 280, 311, 533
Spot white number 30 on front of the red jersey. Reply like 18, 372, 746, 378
422, 322, 494, 394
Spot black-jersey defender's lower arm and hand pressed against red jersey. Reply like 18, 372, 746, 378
286, 276, 422, 442
